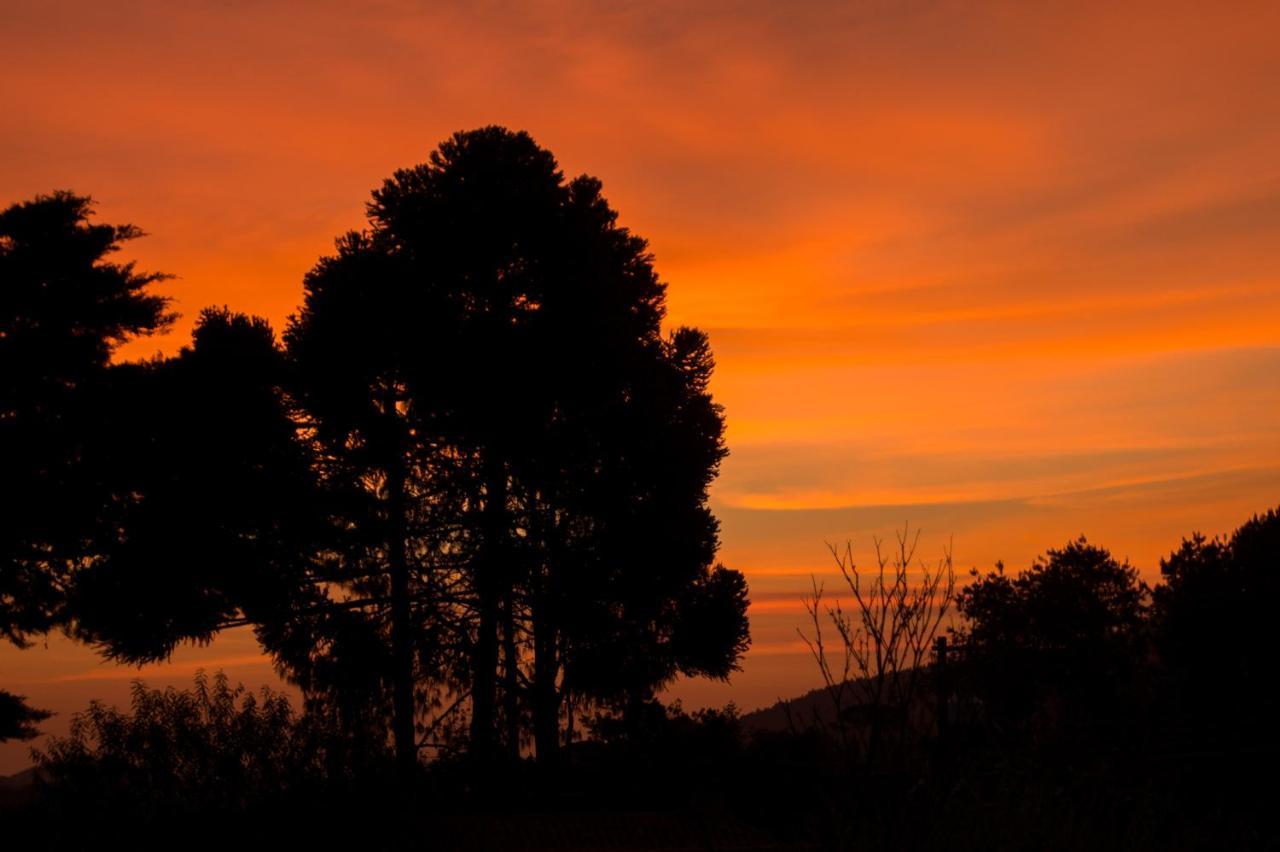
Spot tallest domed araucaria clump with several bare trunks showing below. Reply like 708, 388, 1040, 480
285, 127, 748, 762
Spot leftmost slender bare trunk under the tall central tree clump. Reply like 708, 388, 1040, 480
387, 403, 417, 779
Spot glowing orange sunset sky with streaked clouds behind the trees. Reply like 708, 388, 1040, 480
0, 0, 1280, 773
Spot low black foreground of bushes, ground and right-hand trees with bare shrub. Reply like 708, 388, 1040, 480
5, 512, 1280, 849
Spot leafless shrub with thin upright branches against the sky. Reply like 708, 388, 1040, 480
797, 525, 956, 766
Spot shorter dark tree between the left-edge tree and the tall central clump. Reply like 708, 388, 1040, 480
68, 308, 332, 663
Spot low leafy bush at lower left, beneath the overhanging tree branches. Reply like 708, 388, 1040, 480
35, 672, 385, 821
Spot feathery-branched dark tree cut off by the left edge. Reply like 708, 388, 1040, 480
0, 192, 172, 646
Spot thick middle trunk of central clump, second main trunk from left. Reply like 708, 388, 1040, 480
471, 457, 507, 764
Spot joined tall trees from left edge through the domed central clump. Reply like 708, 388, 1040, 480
0, 128, 749, 777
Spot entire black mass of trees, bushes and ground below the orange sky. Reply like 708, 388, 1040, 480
0, 128, 1280, 849
